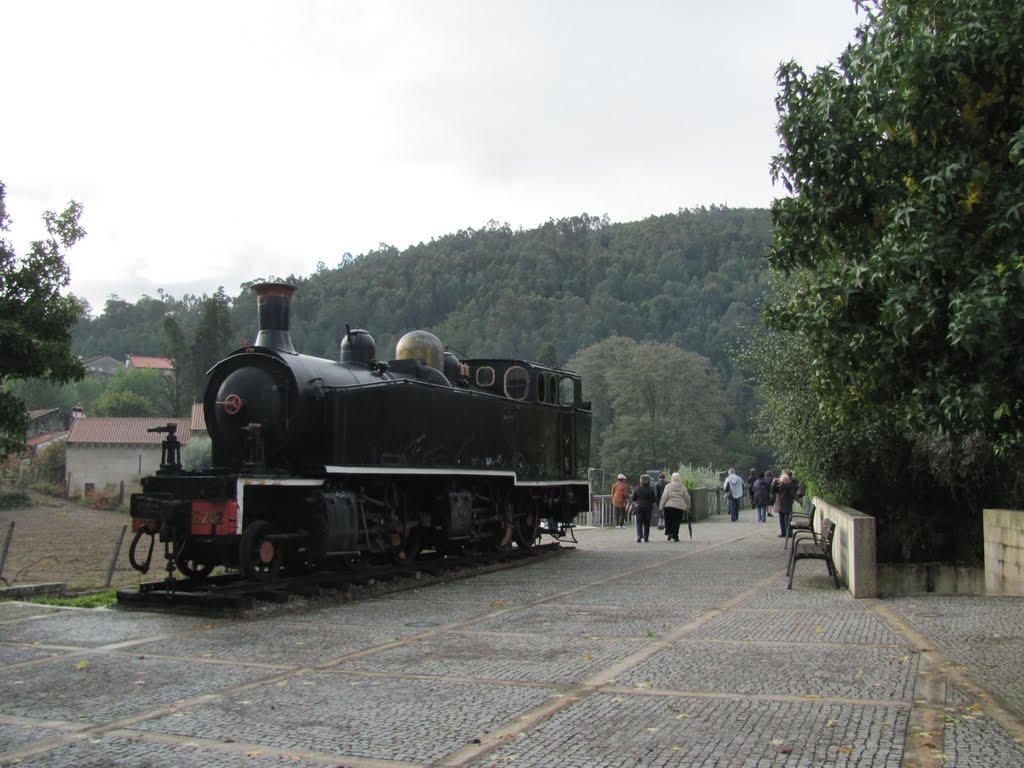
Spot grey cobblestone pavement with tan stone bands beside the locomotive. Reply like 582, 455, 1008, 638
0, 511, 1024, 768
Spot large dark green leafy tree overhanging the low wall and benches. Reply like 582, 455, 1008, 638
765, 0, 1024, 505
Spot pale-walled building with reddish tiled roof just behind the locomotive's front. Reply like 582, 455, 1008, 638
66, 417, 191, 496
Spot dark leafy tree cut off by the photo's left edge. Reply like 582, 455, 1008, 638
0, 182, 85, 458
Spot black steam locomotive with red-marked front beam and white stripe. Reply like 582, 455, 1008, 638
129, 284, 591, 580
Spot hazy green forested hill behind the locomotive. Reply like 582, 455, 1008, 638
74, 207, 770, 388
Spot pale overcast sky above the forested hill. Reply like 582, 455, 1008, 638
0, 0, 862, 312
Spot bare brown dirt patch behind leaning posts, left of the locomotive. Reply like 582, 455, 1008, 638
0, 494, 147, 590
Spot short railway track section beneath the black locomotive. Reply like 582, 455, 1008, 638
117, 542, 574, 614
